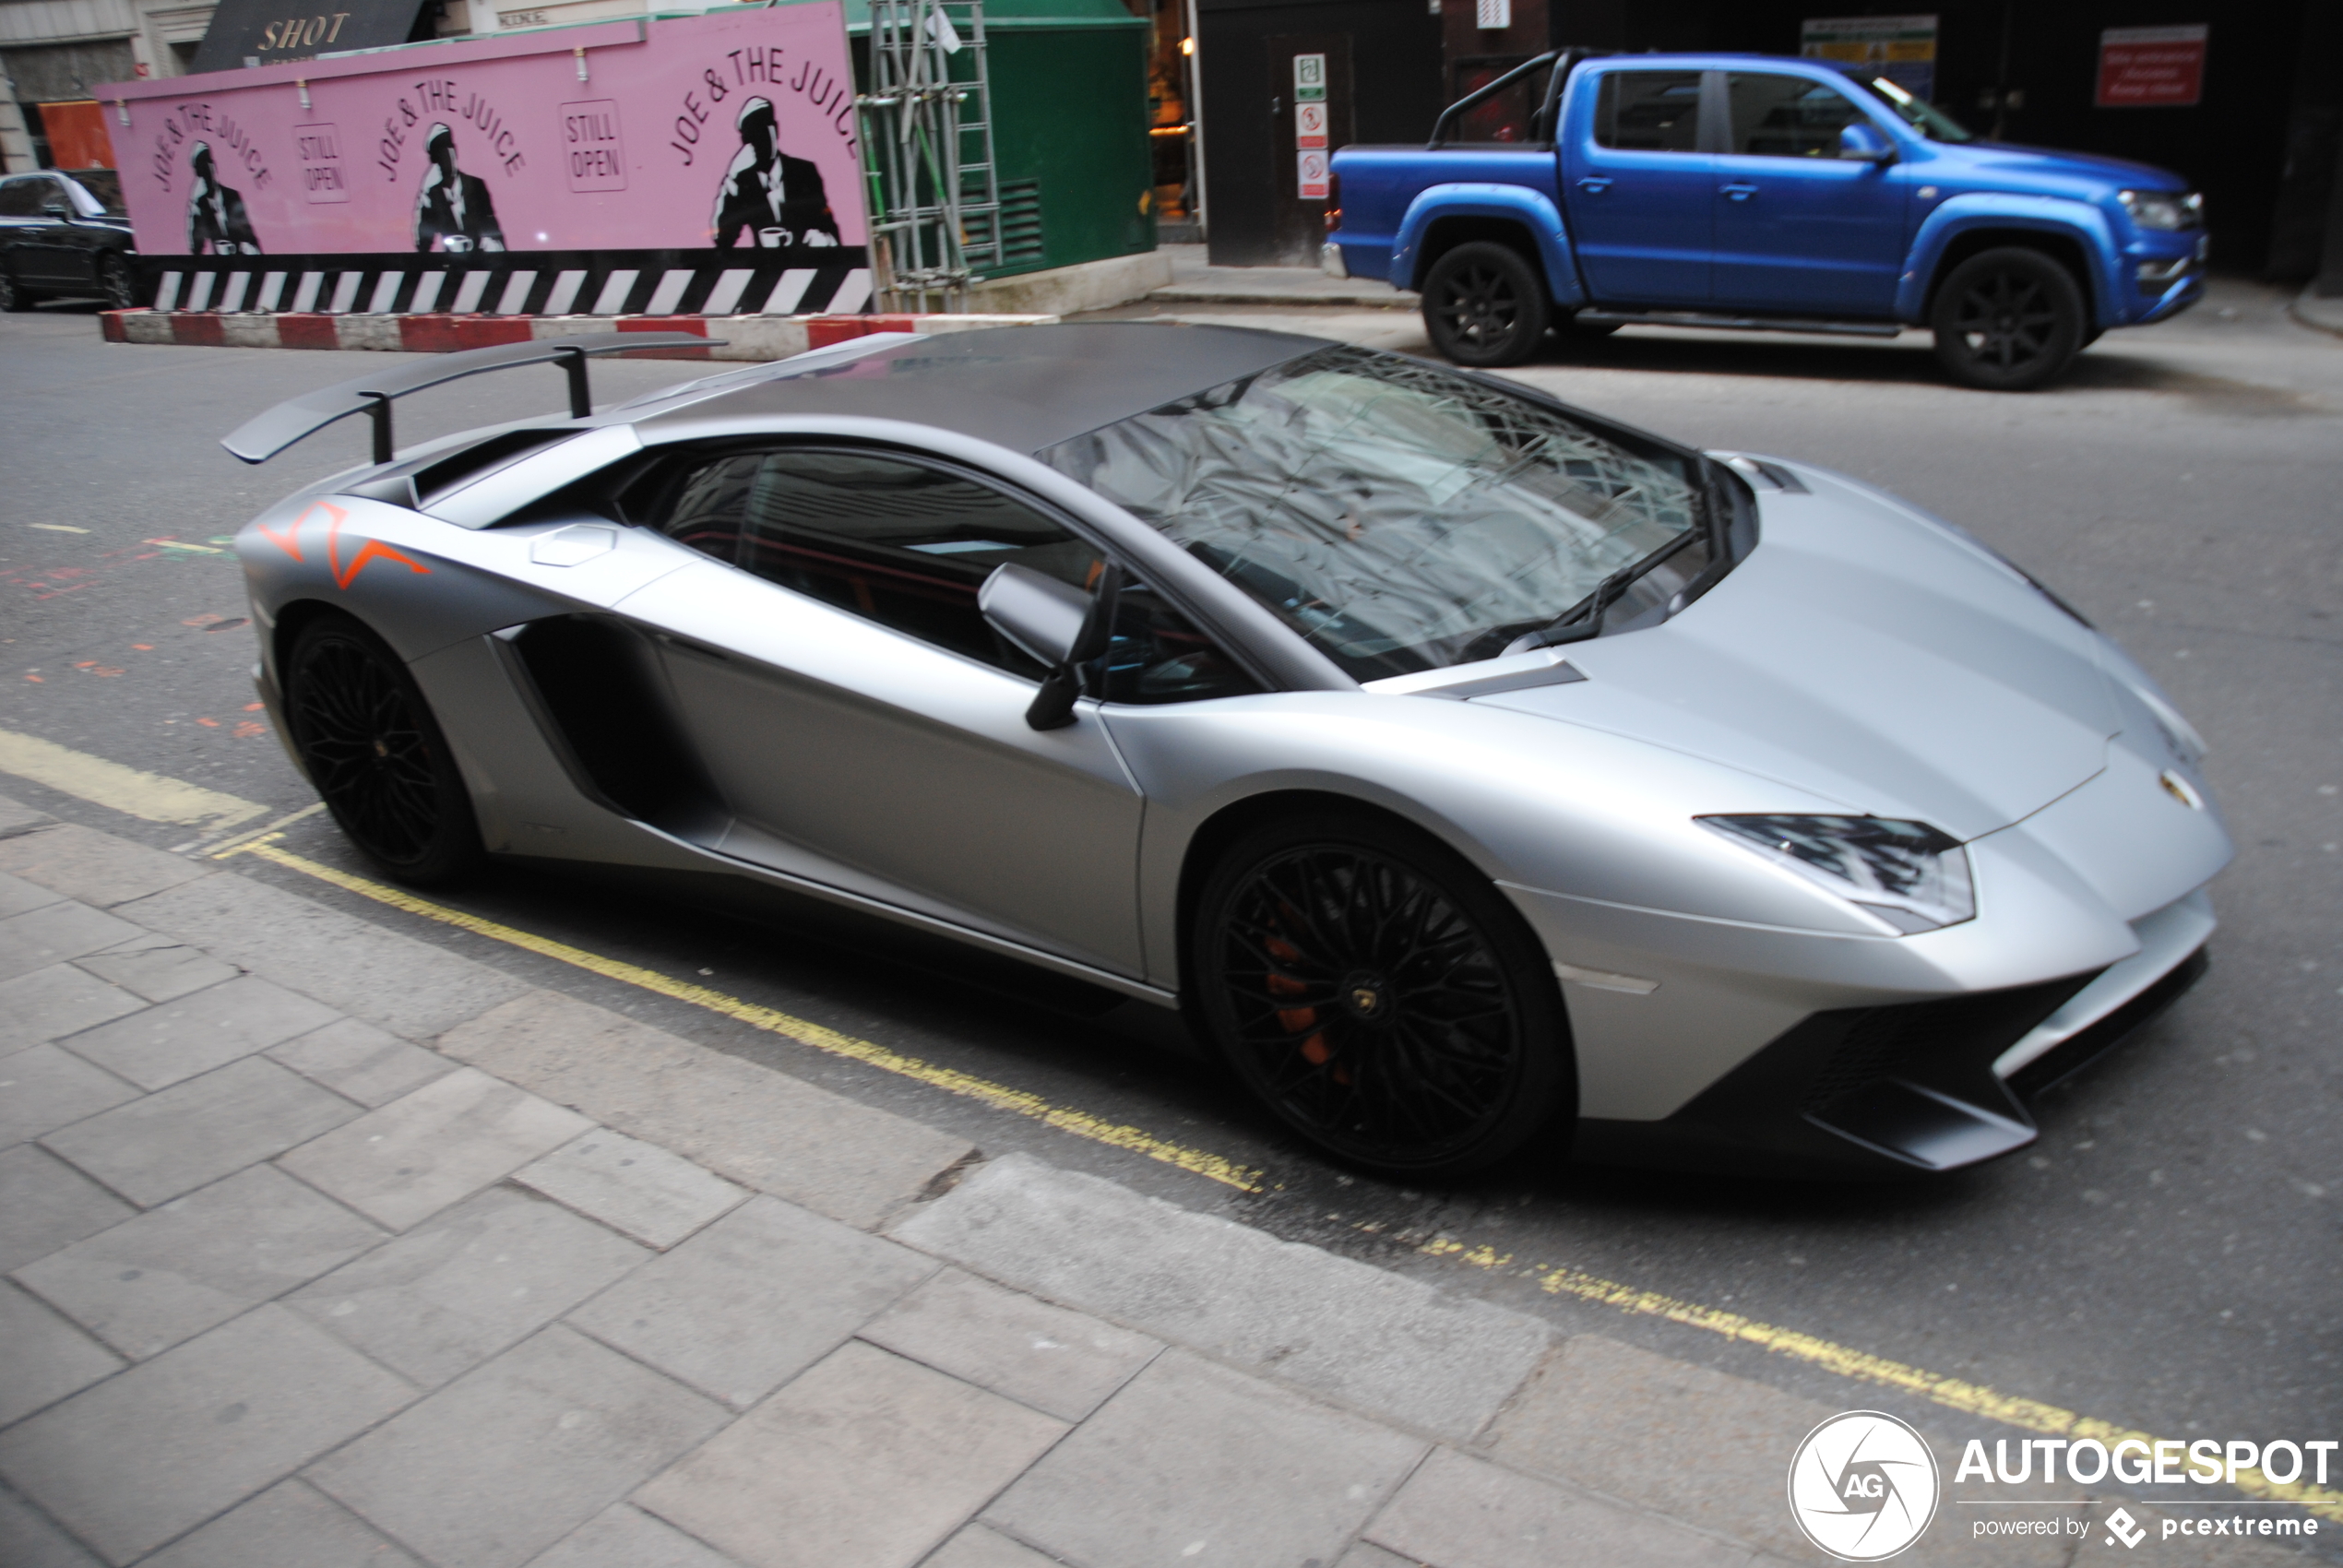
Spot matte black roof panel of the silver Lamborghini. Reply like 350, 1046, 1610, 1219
645, 321, 1326, 452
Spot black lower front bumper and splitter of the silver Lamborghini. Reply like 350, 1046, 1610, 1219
1572, 947, 2209, 1177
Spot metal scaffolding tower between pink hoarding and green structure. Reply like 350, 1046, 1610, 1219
855, 0, 1005, 312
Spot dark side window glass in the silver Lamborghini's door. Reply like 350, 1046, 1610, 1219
659, 447, 1103, 680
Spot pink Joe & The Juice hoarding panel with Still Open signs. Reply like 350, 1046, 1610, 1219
96, 0, 864, 255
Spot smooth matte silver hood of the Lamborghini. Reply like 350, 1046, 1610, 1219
1474, 469, 2123, 839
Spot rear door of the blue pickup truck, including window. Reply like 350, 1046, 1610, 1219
1563, 68, 1715, 304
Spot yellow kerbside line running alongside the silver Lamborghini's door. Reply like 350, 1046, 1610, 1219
213, 835, 1261, 1193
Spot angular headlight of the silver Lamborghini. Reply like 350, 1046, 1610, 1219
1692, 815, 1978, 935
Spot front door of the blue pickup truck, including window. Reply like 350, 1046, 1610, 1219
1715, 70, 1908, 316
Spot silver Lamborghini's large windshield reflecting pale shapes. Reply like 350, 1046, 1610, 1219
1041, 347, 1706, 680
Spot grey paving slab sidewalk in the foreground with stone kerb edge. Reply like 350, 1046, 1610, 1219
0, 800, 2299, 1568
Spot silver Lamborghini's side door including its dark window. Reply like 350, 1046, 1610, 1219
619, 445, 1144, 975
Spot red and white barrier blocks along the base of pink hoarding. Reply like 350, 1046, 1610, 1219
99, 309, 1057, 359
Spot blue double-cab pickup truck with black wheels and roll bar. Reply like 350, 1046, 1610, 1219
1324, 49, 2205, 391
